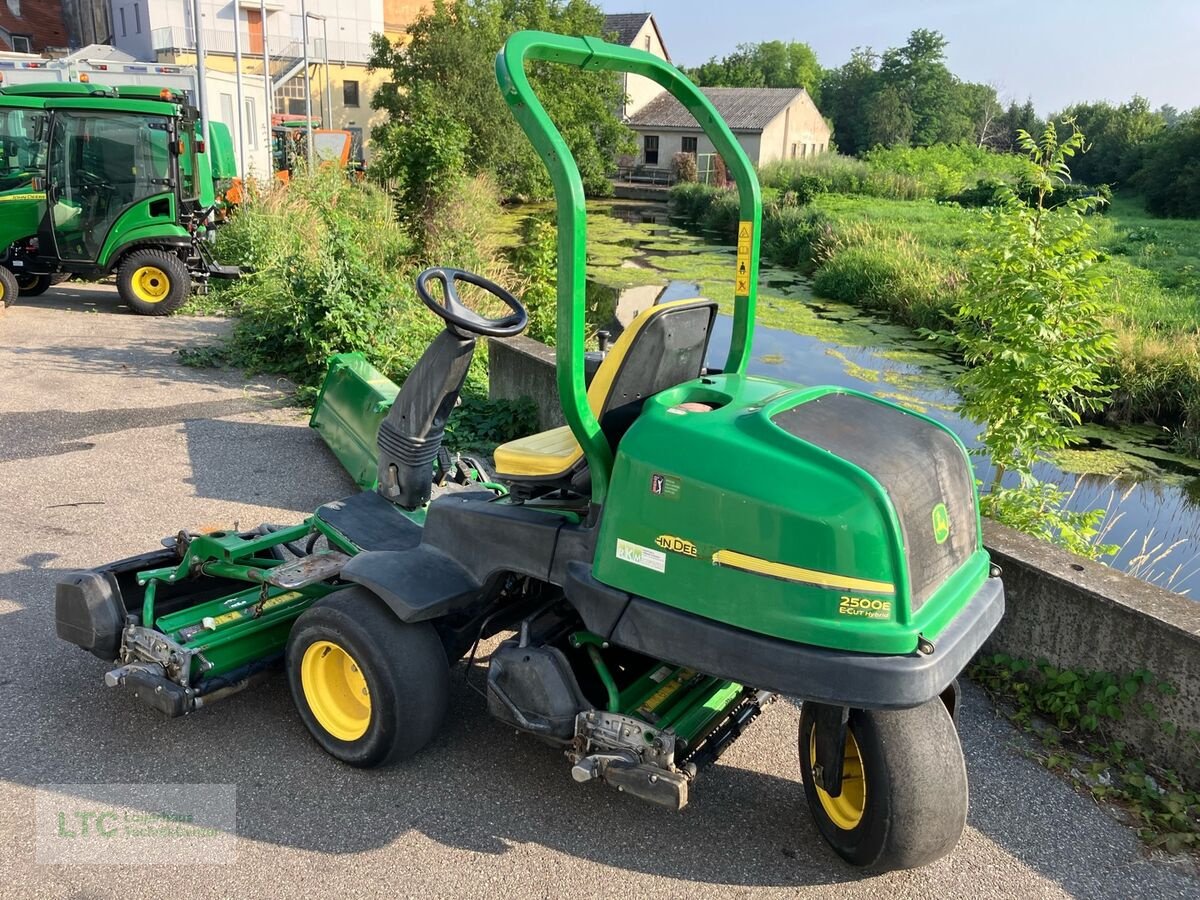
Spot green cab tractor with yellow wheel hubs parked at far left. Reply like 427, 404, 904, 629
0, 83, 239, 316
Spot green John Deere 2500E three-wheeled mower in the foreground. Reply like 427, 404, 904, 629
56, 32, 1003, 869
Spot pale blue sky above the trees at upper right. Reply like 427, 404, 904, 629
599, 0, 1200, 115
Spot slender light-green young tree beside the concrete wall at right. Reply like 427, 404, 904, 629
941, 119, 1114, 556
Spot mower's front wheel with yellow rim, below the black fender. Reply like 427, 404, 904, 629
287, 588, 450, 768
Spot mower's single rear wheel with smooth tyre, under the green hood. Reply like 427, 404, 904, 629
800, 698, 967, 871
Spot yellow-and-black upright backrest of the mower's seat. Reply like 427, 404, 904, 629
588, 300, 716, 449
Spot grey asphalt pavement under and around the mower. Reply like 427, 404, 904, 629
0, 283, 1200, 900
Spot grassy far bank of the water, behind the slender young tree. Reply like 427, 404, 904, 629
671, 185, 1200, 455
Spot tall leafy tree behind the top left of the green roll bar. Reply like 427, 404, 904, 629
371, 0, 635, 202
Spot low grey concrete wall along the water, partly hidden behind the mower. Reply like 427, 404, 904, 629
487, 337, 1200, 784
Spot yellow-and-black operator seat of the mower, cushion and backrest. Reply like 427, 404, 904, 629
496, 300, 716, 497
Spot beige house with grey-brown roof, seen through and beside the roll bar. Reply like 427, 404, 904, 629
626, 88, 830, 174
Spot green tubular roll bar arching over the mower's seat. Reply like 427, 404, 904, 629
496, 31, 762, 506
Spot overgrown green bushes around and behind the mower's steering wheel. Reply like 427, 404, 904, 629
198, 169, 536, 449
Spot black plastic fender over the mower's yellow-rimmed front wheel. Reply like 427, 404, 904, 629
341, 546, 482, 622
